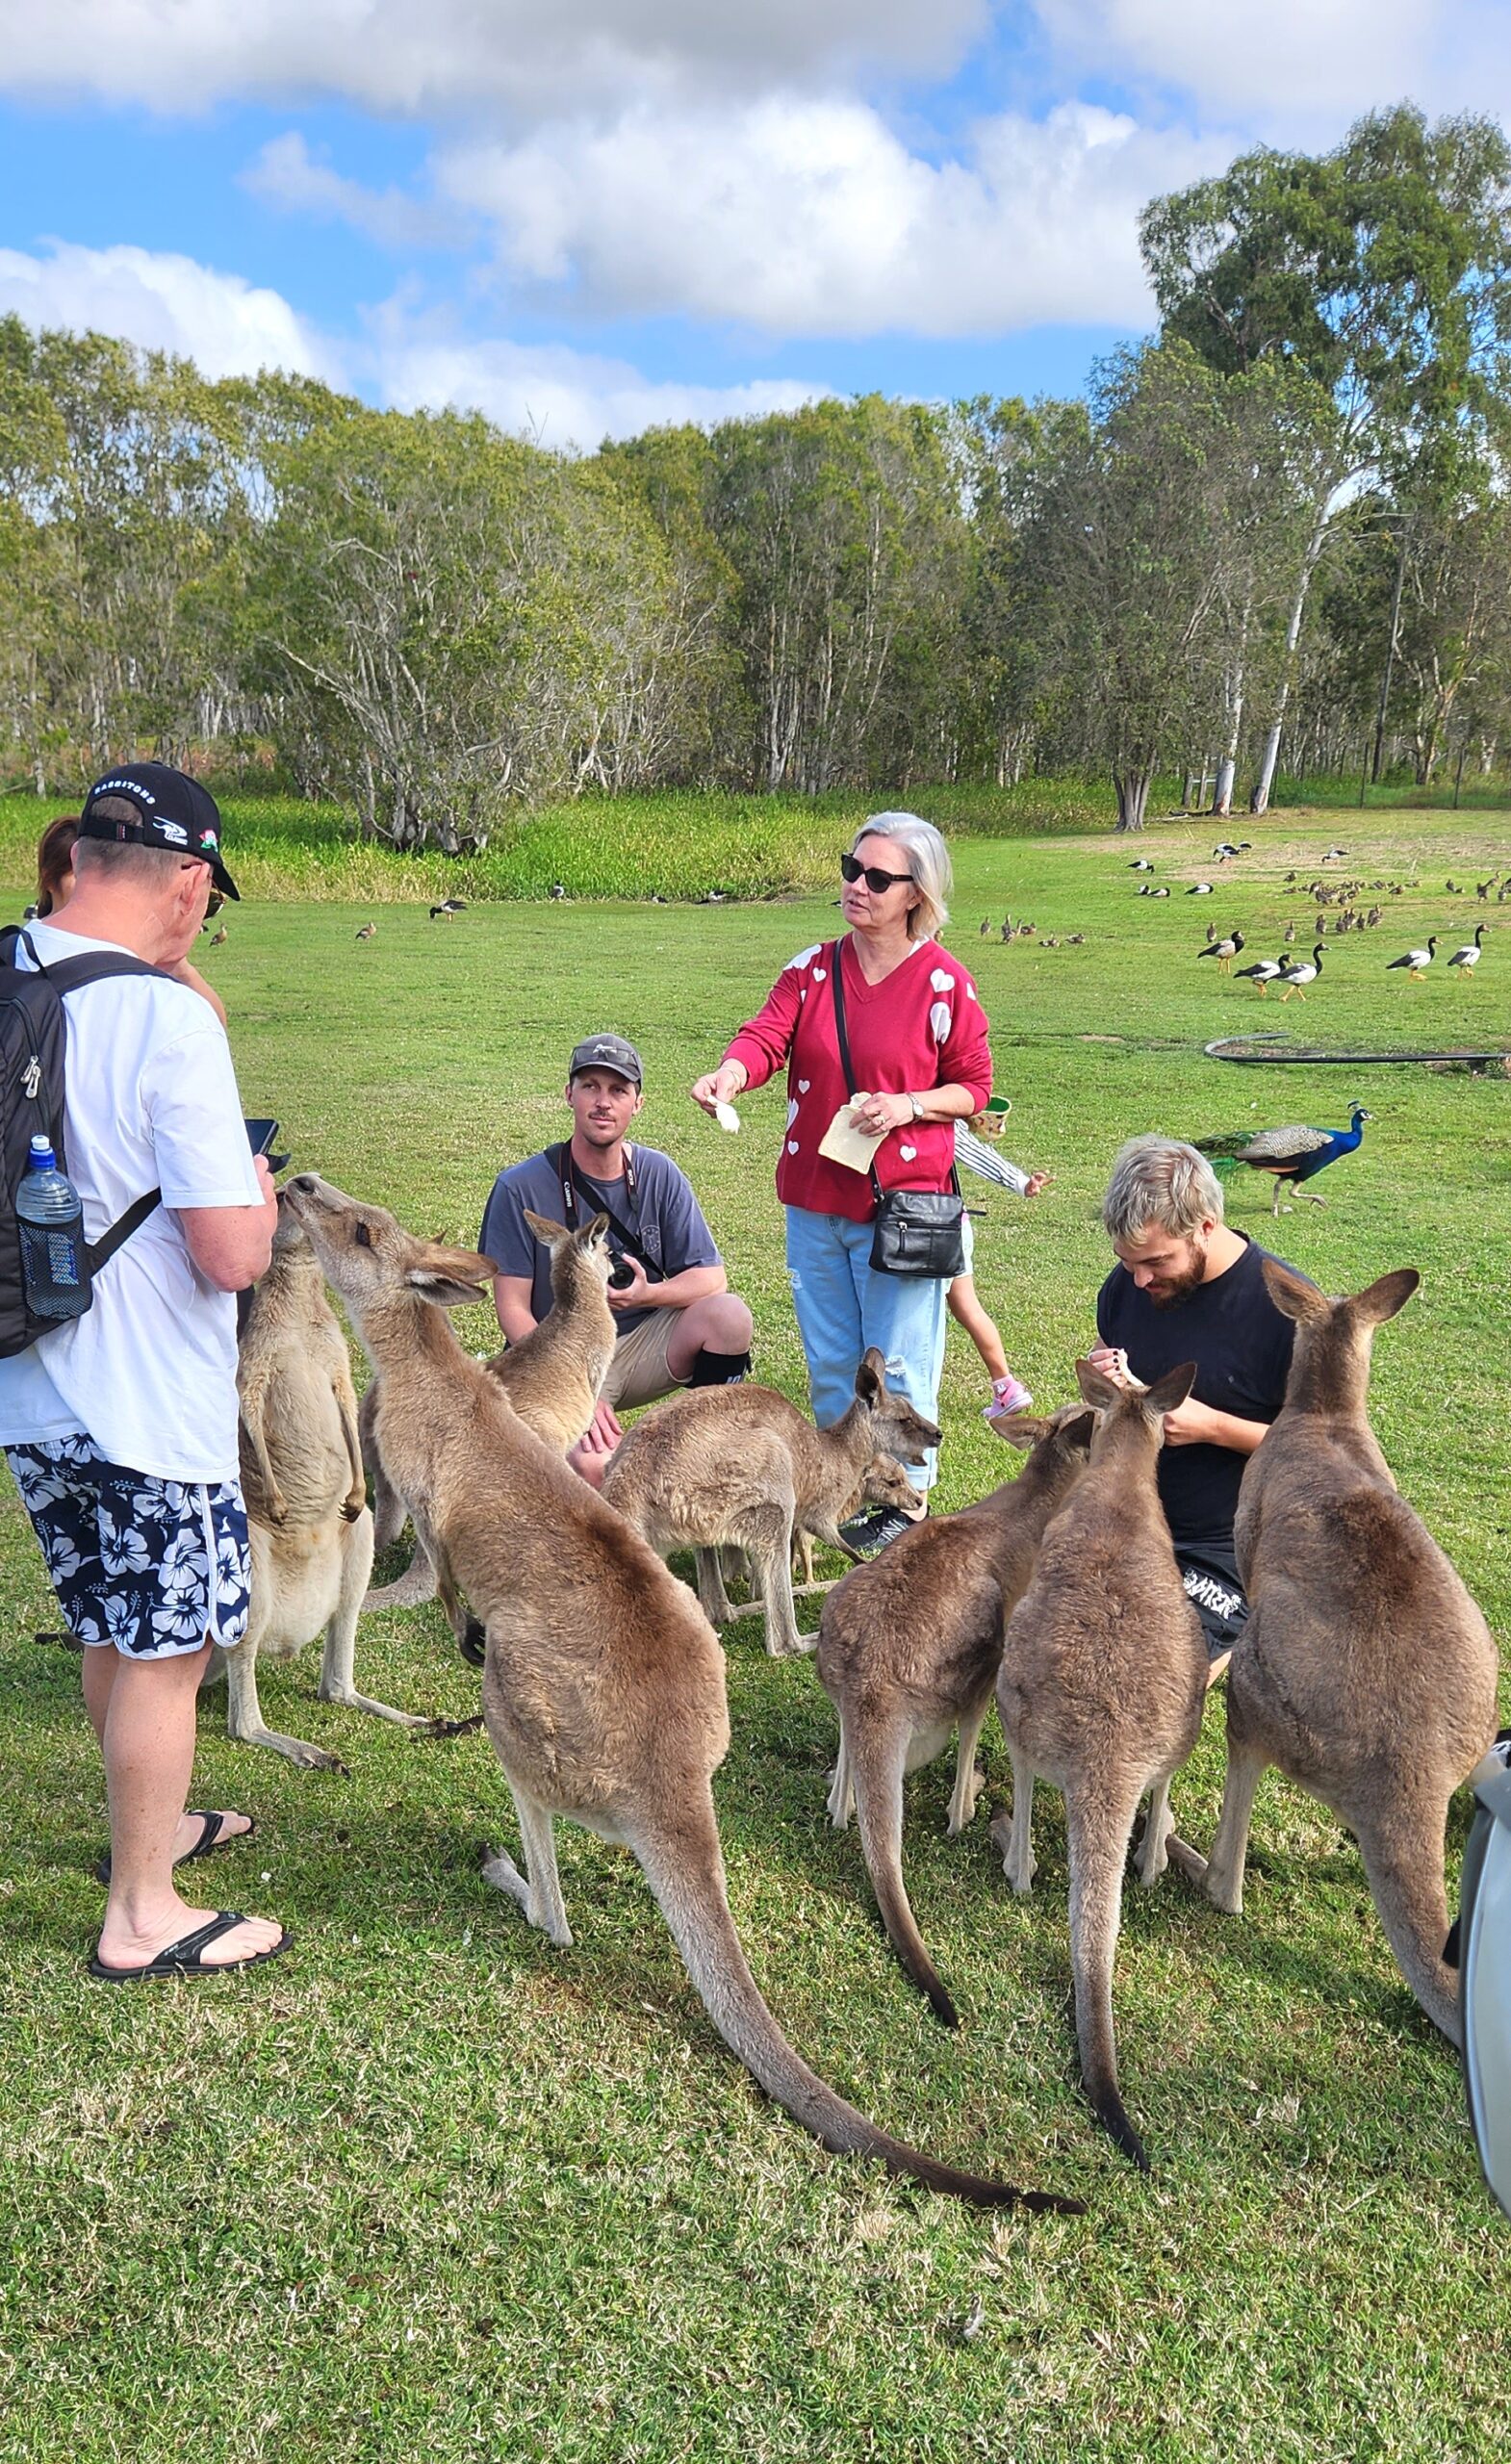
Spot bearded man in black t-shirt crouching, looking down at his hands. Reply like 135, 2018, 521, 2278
1089, 1139, 1296, 1673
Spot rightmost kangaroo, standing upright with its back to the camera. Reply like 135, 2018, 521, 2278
1208, 1259, 1497, 2045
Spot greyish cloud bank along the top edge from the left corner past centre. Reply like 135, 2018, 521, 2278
0, 0, 988, 114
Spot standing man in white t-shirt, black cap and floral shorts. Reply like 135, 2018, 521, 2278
0, 761, 289, 1981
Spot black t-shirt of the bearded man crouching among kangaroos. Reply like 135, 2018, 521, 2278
1097, 1232, 1296, 1550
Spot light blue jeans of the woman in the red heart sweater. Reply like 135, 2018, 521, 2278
786, 1207, 944, 1488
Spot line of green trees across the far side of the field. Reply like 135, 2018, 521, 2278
0, 106, 1511, 853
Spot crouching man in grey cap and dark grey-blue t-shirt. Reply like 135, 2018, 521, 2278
478, 1035, 752, 1488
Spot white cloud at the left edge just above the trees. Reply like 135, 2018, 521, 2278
0, 242, 335, 377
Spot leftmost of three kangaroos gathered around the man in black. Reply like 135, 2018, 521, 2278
818, 1404, 1094, 2028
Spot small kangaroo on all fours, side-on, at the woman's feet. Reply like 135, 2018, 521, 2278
603, 1348, 939, 1658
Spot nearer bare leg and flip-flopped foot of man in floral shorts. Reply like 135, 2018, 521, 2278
84, 1644, 281, 1968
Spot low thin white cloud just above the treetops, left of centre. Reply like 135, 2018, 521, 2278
377, 313, 833, 453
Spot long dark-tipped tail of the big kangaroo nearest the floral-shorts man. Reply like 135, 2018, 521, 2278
631, 1799, 1085, 2215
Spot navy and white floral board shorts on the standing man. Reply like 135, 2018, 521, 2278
5, 1436, 251, 1660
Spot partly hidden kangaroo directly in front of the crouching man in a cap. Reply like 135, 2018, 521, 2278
357, 1207, 619, 1609
